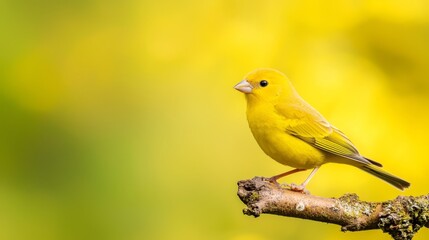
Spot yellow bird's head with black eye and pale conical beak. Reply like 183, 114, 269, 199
234, 68, 295, 101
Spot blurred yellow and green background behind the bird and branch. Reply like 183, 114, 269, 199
0, 0, 429, 240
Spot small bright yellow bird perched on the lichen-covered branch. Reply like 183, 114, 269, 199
234, 68, 410, 191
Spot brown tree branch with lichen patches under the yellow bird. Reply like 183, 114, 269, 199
237, 177, 429, 240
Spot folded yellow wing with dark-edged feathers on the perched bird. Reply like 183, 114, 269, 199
276, 102, 381, 167
